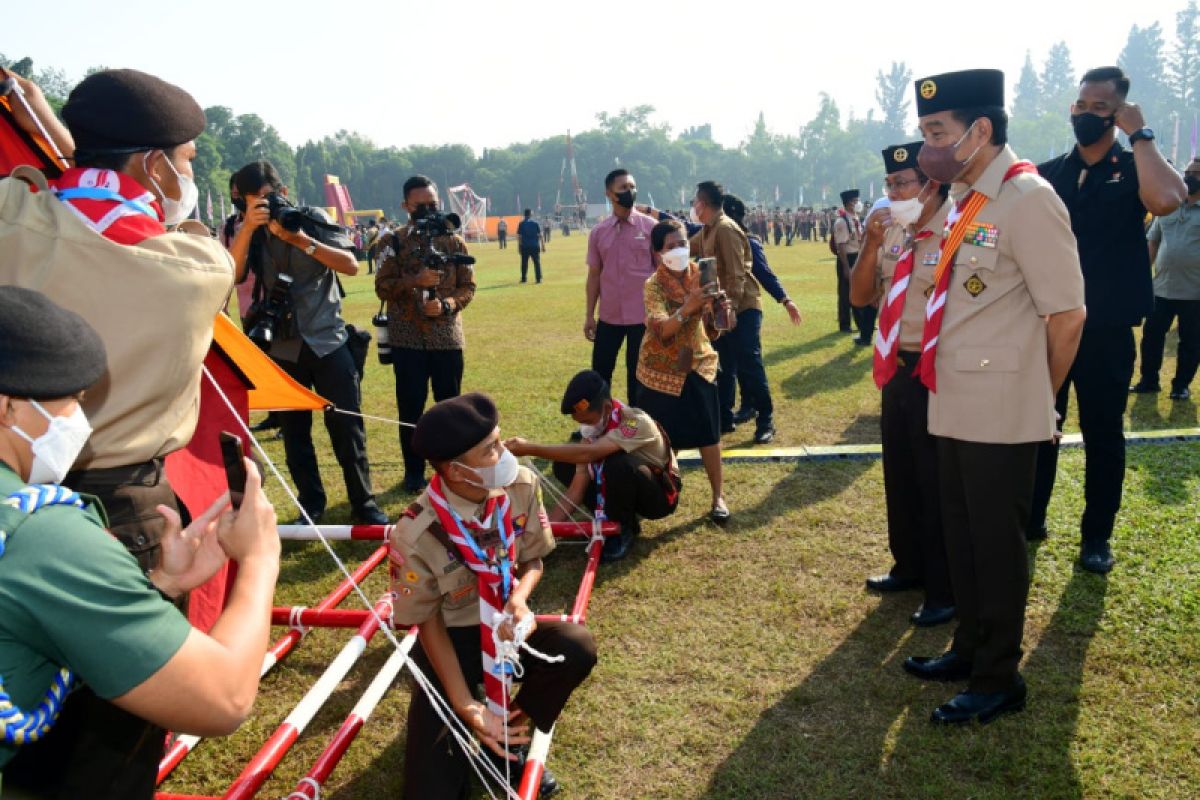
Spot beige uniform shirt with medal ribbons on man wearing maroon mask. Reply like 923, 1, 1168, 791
929, 146, 1084, 444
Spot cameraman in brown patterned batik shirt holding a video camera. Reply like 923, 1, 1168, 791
376, 175, 475, 493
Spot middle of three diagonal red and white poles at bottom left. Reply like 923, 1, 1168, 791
222, 594, 391, 800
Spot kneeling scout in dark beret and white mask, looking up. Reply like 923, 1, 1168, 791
389, 392, 596, 800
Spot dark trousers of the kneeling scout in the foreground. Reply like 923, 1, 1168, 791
404, 622, 596, 800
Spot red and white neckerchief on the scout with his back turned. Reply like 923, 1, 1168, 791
54, 167, 167, 245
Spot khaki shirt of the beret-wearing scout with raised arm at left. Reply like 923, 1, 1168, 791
0, 179, 233, 469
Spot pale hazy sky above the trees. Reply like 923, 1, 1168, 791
7, 0, 1187, 154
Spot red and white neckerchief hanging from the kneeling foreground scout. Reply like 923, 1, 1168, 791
426, 475, 516, 720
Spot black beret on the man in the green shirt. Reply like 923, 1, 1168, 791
0, 287, 108, 399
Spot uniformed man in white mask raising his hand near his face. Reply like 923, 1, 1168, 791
850, 142, 954, 627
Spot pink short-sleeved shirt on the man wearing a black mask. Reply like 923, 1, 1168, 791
588, 209, 658, 325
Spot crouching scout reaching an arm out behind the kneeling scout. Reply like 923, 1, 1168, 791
504, 369, 680, 561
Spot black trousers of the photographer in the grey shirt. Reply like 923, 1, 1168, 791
276, 343, 374, 516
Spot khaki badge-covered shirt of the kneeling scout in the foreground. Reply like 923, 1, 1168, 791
388, 467, 554, 627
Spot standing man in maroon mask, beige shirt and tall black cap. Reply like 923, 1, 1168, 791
904, 70, 1085, 723
